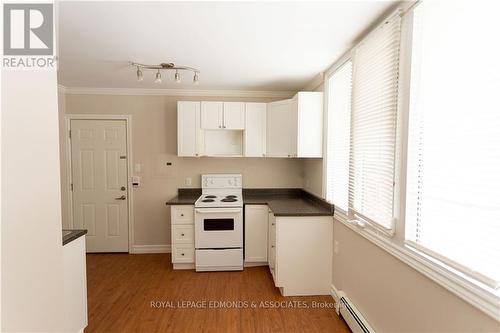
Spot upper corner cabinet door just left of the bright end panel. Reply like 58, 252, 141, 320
267, 99, 297, 157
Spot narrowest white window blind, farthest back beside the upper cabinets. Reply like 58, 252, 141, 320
326, 60, 352, 212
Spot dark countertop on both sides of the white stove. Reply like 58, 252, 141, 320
166, 189, 333, 216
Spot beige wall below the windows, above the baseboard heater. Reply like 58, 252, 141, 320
333, 221, 500, 333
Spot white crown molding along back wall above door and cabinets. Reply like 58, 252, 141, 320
58, 85, 295, 98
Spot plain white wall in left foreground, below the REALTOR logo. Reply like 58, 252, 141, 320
1, 70, 63, 332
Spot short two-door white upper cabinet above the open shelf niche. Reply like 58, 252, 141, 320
201, 102, 245, 130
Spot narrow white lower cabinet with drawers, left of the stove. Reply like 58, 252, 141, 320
170, 205, 194, 269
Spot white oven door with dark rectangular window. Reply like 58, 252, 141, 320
194, 208, 243, 249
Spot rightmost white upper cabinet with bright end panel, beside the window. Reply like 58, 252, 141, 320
267, 92, 323, 158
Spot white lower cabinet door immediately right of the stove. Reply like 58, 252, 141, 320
245, 205, 268, 262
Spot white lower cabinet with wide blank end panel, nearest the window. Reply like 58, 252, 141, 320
268, 212, 333, 296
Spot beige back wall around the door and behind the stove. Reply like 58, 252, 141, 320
60, 94, 303, 245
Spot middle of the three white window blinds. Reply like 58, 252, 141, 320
349, 15, 401, 233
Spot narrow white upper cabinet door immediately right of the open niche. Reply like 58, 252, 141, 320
245, 103, 267, 157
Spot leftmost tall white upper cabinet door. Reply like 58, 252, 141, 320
177, 101, 200, 156
